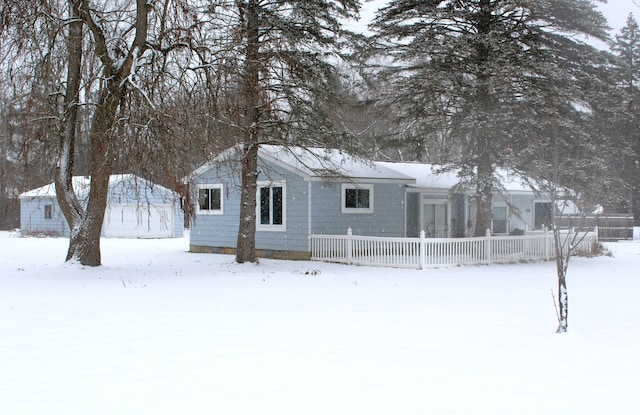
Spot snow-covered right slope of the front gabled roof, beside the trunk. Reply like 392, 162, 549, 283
260, 145, 414, 182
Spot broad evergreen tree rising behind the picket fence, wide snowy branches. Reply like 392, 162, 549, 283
371, 0, 607, 235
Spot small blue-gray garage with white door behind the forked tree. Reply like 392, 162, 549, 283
20, 174, 184, 238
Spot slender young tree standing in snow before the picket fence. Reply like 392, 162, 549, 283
517, 86, 628, 333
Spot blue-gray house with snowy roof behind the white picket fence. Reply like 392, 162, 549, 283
188, 145, 549, 258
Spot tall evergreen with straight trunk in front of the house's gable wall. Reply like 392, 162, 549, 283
200, 0, 360, 263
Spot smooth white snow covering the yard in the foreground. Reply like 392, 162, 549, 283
0, 232, 640, 415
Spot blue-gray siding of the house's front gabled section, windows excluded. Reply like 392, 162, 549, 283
190, 158, 405, 257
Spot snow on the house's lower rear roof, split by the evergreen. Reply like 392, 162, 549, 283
376, 161, 532, 193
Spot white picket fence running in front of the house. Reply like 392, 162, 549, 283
311, 228, 598, 269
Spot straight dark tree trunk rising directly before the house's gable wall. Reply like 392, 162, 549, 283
236, 0, 261, 263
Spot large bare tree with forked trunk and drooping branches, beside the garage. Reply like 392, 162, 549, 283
2, 0, 214, 266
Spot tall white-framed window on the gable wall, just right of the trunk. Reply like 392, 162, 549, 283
257, 182, 286, 231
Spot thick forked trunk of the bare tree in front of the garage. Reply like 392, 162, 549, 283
55, 0, 150, 266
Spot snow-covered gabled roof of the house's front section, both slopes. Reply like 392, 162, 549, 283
191, 145, 414, 183
